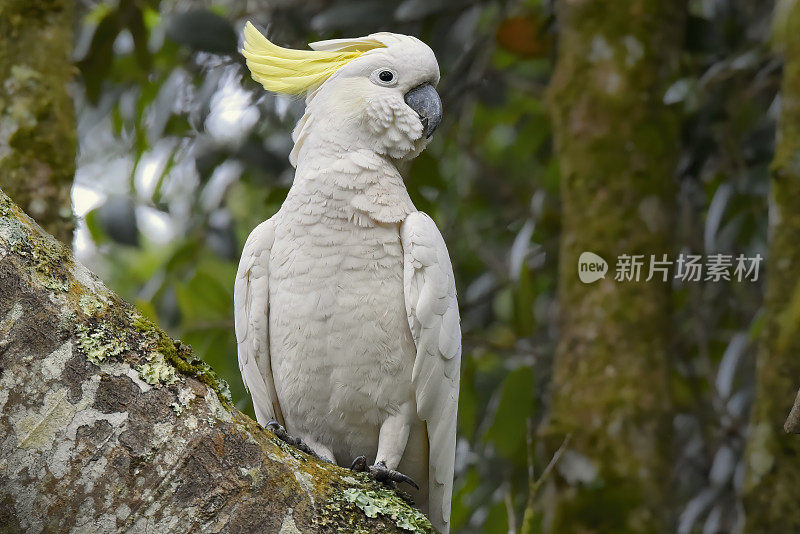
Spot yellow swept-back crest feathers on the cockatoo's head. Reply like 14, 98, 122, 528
242, 22, 385, 95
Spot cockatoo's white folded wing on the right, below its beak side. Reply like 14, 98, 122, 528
400, 212, 461, 525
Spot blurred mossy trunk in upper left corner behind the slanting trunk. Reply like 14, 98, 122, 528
0, 0, 76, 244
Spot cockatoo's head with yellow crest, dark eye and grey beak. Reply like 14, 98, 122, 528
242, 22, 442, 163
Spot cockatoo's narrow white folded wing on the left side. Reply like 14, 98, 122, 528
233, 220, 284, 425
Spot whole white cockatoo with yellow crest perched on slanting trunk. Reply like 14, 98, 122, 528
234, 23, 461, 532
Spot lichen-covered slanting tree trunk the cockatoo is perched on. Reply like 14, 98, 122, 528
0, 191, 433, 534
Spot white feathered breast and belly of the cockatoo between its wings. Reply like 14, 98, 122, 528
269, 201, 415, 452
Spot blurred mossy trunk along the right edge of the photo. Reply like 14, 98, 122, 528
745, 0, 800, 533
